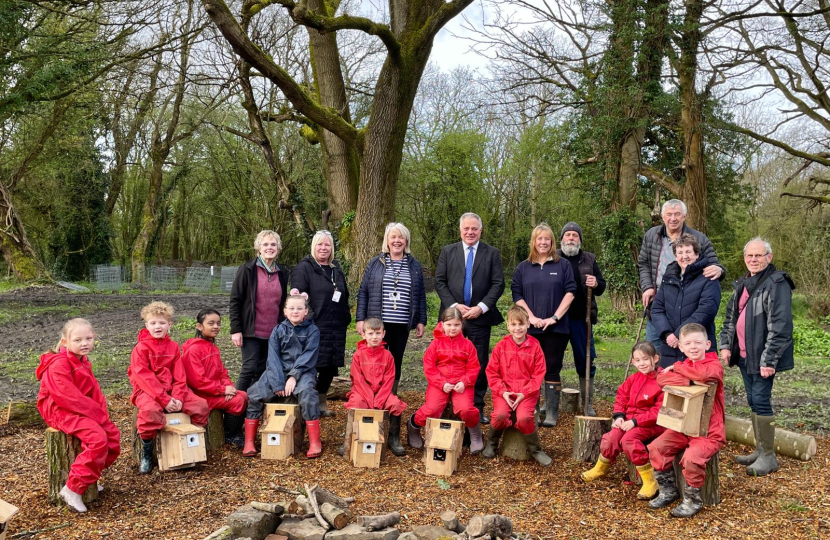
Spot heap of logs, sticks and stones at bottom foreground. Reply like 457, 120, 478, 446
205, 484, 519, 540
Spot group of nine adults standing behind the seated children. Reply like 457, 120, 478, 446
224, 199, 795, 474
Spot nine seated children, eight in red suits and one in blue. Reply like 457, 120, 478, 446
37, 291, 725, 516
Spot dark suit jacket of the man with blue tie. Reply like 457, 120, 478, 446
435, 242, 504, 326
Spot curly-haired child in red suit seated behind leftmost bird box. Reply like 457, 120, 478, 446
127, 302, 210, 474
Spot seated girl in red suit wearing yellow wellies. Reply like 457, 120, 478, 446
582, 341, 666, 500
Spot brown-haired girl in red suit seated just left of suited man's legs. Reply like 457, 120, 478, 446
407, 307, 484, 455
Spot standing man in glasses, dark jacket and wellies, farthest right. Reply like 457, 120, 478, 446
718, 238, 795, 476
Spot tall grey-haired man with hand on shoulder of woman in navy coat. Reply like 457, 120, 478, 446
637, 199, 726, 351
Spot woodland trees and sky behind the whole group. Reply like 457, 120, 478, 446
0, 0, 830, 316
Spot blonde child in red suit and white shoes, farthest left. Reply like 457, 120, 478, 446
36, 319, 121, 512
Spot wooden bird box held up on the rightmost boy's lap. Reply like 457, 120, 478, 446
657, 384, 717, 437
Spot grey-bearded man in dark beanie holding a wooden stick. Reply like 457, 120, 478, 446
557, 221, 605, 416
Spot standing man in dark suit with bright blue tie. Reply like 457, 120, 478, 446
435, 212, 504, 424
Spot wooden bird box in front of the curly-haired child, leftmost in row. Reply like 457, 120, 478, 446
157, 413, 207, 471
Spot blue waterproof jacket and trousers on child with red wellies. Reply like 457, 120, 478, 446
245, 319, 320, 420
